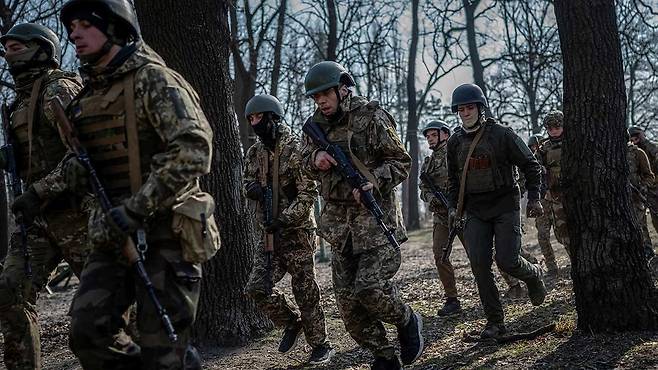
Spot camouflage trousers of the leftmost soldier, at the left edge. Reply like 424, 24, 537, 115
0, 212, 88, 369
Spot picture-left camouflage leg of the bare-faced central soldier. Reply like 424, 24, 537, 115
331, 240, 395, 359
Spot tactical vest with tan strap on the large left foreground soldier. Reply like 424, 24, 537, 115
69, 67, 165, 198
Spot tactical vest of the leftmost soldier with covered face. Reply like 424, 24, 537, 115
11, 70, 80, 183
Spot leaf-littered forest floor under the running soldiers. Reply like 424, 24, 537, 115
5, 222, 658, 370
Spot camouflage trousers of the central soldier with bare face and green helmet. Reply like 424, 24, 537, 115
331, 235, 412, 358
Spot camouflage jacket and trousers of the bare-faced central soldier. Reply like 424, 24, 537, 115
302, 96, 412, 359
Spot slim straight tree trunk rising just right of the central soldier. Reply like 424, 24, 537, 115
406, 0, 420, 230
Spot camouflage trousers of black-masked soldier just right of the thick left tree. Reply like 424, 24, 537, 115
245, 229, 327, 348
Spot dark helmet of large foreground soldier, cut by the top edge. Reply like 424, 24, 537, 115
59, 0, 141, 43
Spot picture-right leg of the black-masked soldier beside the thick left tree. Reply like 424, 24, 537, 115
286, 230, 327, 348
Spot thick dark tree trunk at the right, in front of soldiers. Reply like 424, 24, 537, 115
555, 0, 658, 332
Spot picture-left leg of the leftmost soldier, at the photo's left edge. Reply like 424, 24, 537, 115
0, 225, 61, 369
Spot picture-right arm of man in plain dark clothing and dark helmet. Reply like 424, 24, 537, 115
505, 129, 542, 200
